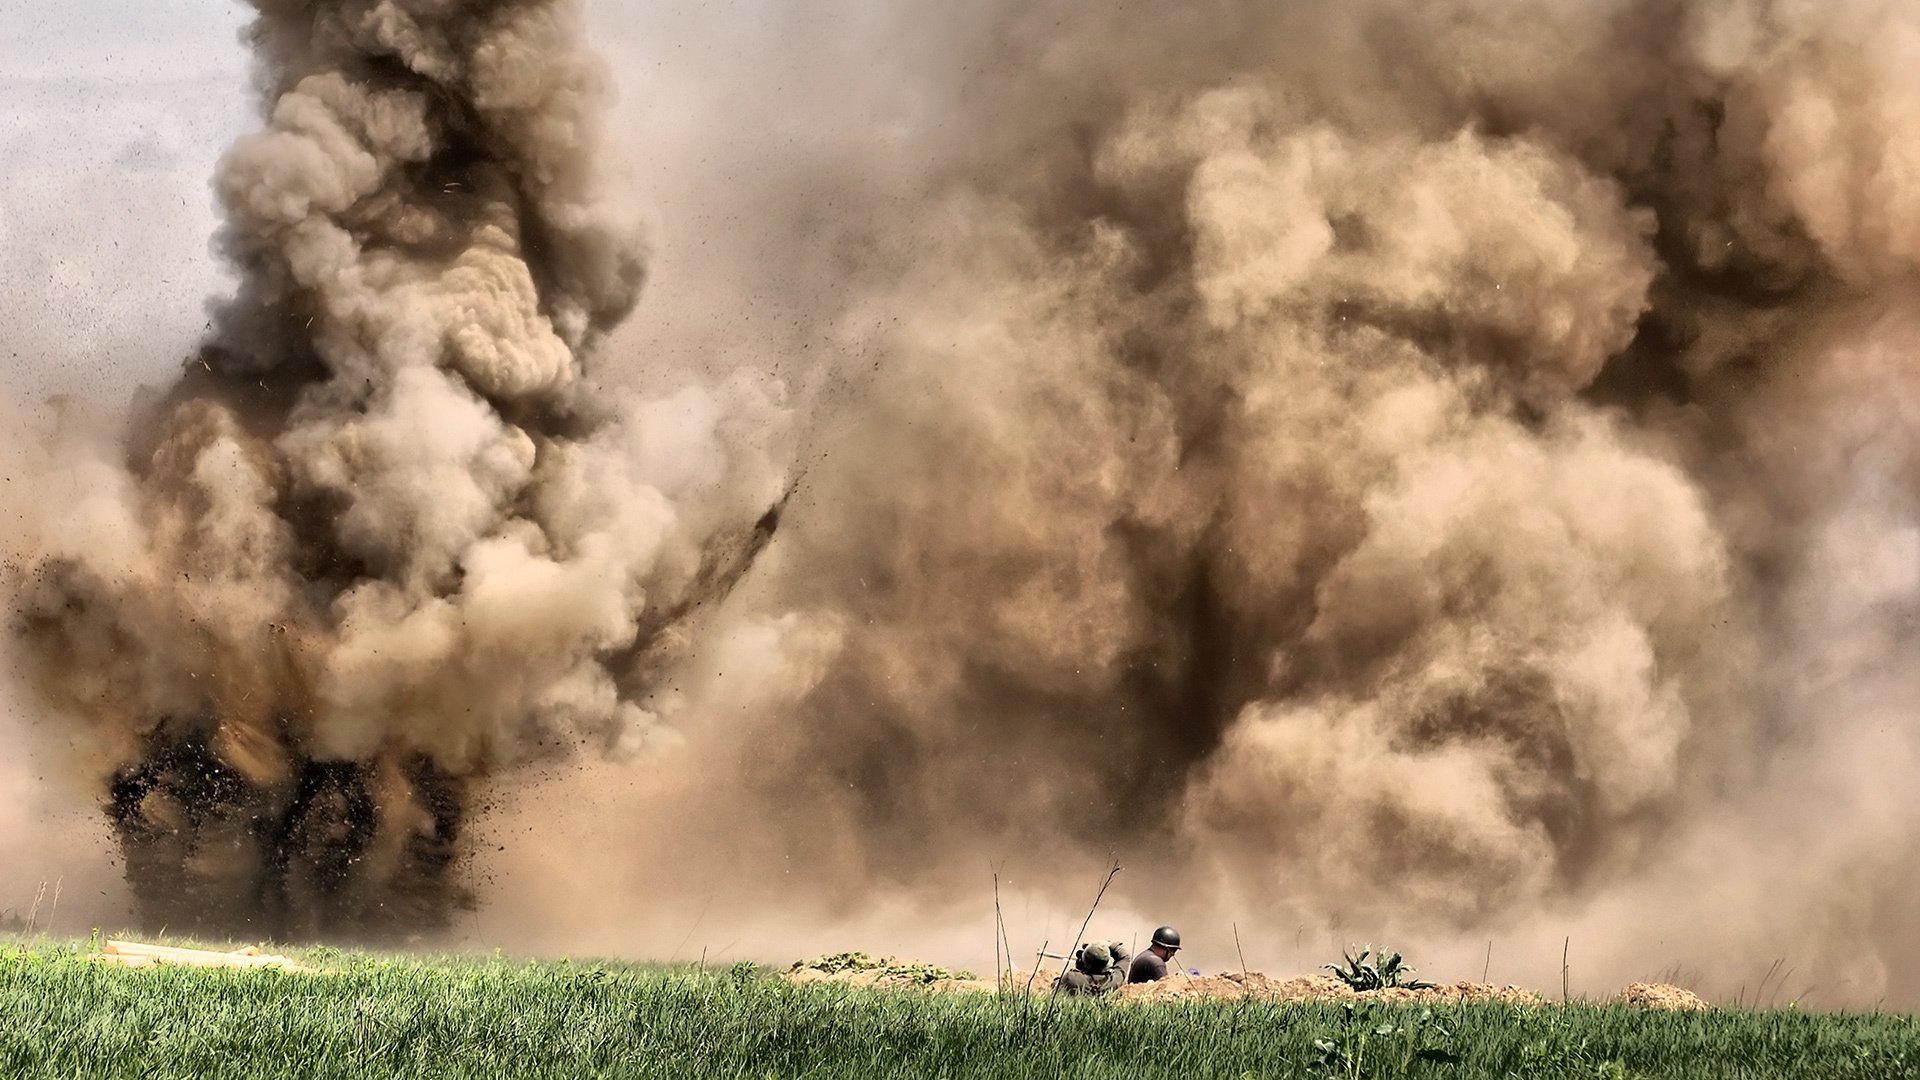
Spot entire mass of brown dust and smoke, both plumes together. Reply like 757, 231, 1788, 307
3, 0, 1920, 1003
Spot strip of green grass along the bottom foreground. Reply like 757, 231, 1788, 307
0, 944, 1920, 1080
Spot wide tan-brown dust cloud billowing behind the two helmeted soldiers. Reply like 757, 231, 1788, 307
518, 0, 1920, 999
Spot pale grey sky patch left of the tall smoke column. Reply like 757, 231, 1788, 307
0, 0, 250, 402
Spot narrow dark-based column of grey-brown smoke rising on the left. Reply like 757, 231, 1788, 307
21, 0, 781, 932
